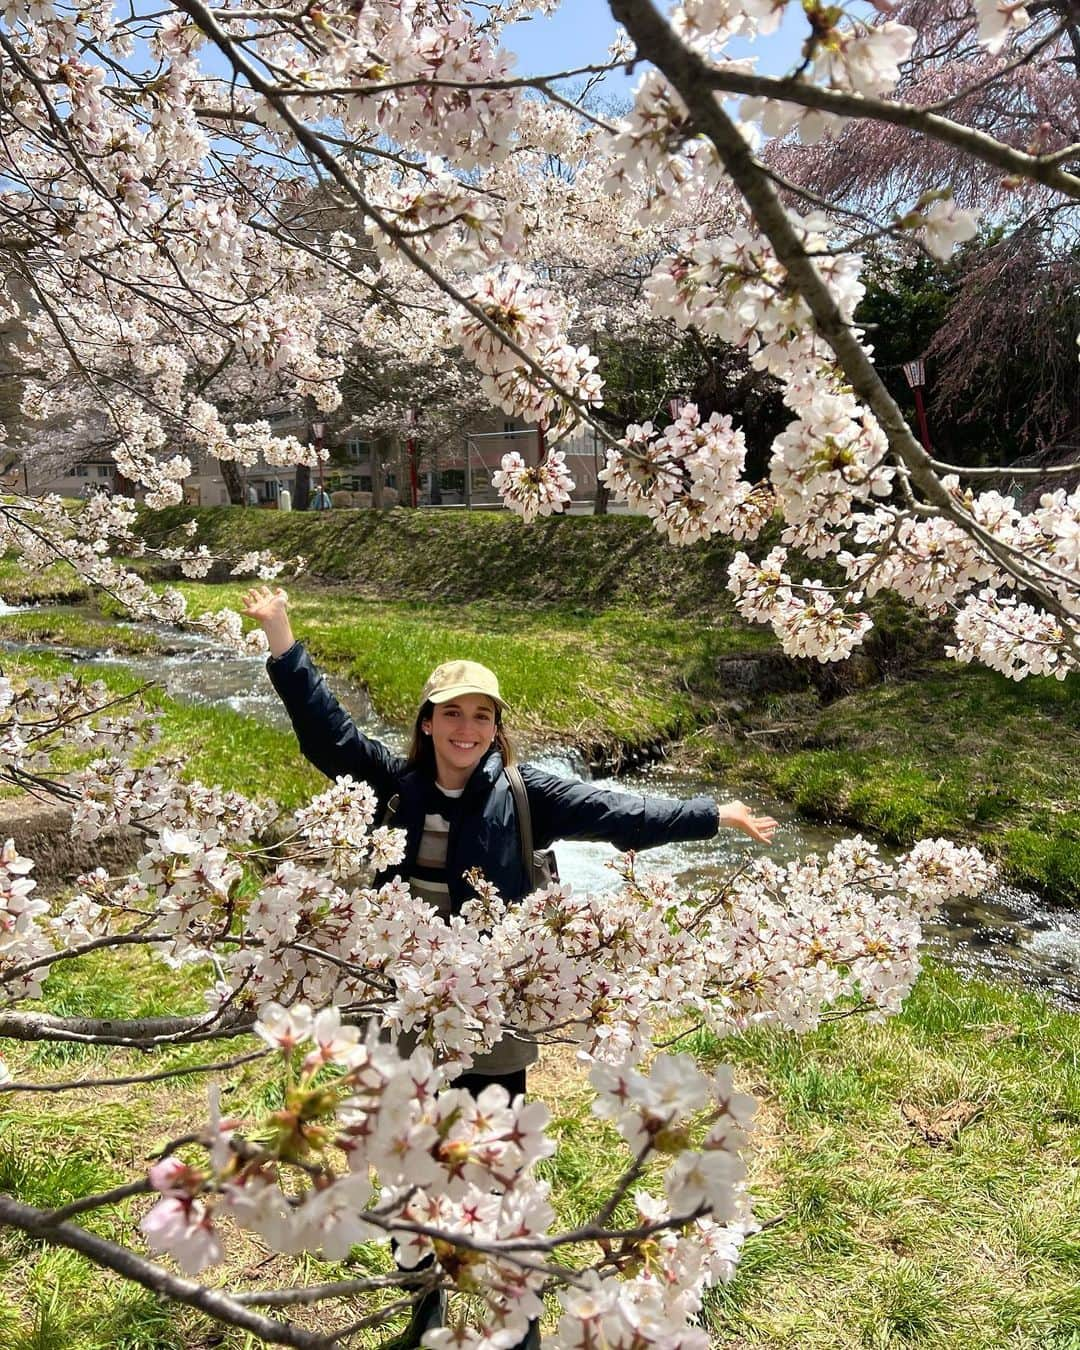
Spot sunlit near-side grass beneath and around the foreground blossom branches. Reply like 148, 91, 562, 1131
0, 952, 1080, 1350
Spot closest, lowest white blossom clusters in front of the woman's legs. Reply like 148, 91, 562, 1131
139, 1003, 755, 1350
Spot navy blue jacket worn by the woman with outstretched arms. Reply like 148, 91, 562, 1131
266, 643, 718, 913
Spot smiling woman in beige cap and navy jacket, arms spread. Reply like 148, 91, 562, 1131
244, 586, 776, 1347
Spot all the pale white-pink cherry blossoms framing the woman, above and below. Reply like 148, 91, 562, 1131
0, 0, 1080, 1333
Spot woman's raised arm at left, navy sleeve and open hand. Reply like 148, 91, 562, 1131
242, 586, 405, 809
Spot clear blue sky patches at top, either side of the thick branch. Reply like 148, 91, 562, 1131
504, 0, 809, 82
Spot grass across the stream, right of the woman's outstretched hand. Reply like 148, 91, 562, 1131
701, 663, 1080, 902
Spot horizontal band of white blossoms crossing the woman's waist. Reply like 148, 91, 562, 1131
4, 760, 988, 1068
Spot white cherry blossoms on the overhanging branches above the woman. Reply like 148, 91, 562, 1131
0, 0, 1077, 675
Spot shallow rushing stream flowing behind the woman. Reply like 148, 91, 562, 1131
8, 618, 1080, 1011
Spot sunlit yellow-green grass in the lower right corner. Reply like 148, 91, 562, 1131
697, 968, 1080, 1350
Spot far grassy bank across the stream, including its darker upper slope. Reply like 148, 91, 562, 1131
0, 508, 1080, 902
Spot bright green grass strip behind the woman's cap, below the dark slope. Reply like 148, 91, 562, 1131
0, 594, 771, 764
